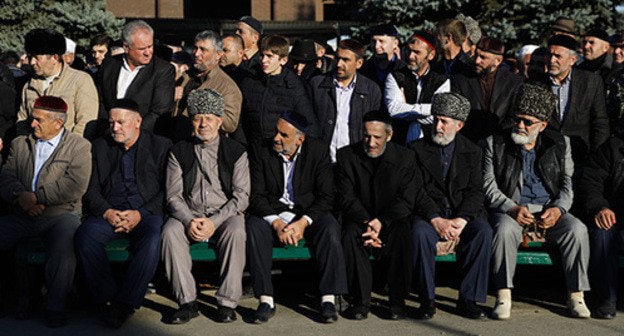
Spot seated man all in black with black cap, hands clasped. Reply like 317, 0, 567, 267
336, 111, 422, 320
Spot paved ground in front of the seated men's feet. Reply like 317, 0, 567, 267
0, 264, 624, 336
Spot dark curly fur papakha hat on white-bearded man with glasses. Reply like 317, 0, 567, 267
513, 84, 557, 121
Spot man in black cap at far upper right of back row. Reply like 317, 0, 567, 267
578, 29, 613, 85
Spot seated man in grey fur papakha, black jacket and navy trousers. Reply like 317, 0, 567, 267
409, 93, 492, 319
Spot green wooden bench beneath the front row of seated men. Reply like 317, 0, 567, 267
28, 239, 560, 266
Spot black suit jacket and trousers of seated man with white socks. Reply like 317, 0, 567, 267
246, 138, 347, 296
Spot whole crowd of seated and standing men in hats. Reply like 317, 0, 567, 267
0, 15, 624, 328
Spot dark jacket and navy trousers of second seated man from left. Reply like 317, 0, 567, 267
75, 131, 171, 308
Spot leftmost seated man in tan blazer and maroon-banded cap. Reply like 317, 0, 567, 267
0, 96, 91, 328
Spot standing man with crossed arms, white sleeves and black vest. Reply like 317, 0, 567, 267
384, 31, 451, 144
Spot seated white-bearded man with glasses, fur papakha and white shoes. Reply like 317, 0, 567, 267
483, 84, 590, 320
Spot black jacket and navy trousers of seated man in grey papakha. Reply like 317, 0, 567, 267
409, 134, 492, 302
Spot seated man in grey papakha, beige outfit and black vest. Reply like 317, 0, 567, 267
162, 89, 250, 324
